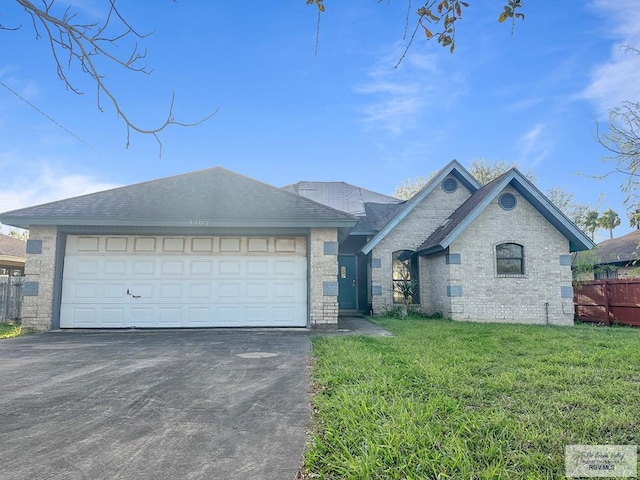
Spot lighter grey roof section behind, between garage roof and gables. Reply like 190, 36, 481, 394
282, 182, 403, 217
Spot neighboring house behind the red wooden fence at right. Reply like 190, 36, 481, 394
574, 230, 640, 281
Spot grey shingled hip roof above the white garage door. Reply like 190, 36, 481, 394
0, 167, 357, 227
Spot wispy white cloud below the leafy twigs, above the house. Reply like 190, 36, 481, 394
355, 48, 463, 135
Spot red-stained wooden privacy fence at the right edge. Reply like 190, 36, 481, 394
573, 278, 640, 326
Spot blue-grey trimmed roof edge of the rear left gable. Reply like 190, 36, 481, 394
362, 160, 480, 254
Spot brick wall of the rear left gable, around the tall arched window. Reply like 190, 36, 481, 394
371, 178, 470, 315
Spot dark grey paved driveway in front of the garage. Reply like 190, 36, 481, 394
0, 330, 310, 480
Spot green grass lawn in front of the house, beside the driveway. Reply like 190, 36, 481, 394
303, 319, 640, 480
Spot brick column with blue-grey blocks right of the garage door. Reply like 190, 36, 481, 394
309, 228, 338, 328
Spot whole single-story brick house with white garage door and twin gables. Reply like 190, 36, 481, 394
0, 161, 593, 330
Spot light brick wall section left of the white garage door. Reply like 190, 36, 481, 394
22, 226, 58, 331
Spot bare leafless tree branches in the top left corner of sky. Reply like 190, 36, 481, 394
8, 0, 217, 156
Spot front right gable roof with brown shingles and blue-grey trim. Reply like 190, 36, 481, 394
417, 168, 593, 254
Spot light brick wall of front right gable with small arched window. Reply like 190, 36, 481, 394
440, 189, 573, 325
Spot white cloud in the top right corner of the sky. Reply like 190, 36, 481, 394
583, 0, 640, 115
